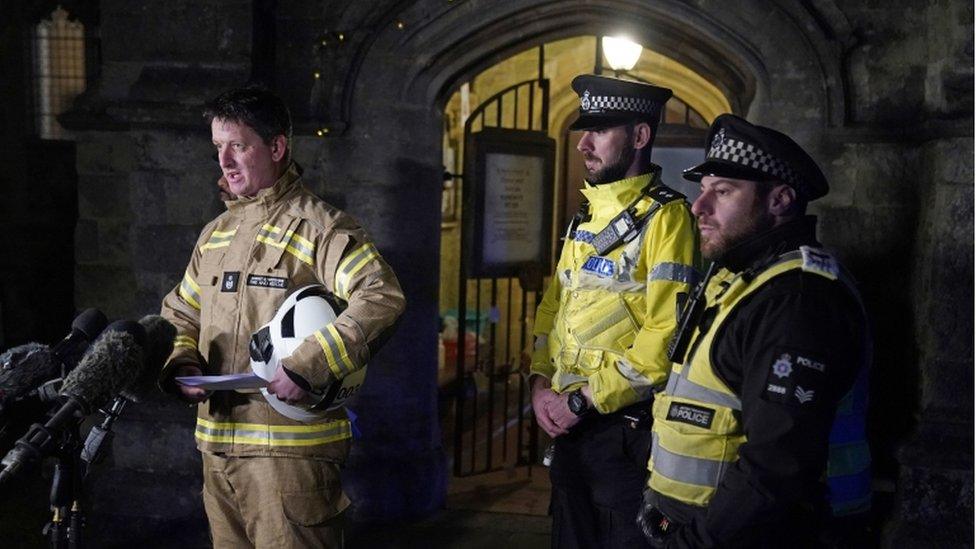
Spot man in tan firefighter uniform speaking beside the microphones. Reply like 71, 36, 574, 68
160, 88, 404, 547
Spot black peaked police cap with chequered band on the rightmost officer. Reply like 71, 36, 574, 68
683, 114, 829, 201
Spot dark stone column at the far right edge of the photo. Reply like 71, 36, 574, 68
884, 138, 974, 547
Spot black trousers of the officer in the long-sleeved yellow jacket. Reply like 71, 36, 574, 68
549, 402, 651, 549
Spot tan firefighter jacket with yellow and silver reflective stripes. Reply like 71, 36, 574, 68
160, 163, 404, 458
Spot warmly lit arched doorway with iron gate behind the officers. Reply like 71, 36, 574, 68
438, 36, 732, 514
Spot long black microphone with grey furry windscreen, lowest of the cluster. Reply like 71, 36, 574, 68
0, 320, 146, 484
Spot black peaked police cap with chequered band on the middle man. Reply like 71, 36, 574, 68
569, 74, 671, 130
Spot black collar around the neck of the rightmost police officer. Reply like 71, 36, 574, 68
717, 215, 820, 273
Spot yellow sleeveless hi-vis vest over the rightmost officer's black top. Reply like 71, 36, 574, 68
648, 246, 858, 506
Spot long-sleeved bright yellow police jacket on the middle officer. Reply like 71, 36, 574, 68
531, 168, 698, 414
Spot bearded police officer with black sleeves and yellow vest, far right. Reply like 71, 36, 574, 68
638, 115, 868, 547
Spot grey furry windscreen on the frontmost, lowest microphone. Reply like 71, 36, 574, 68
61, 331, 145, 413
